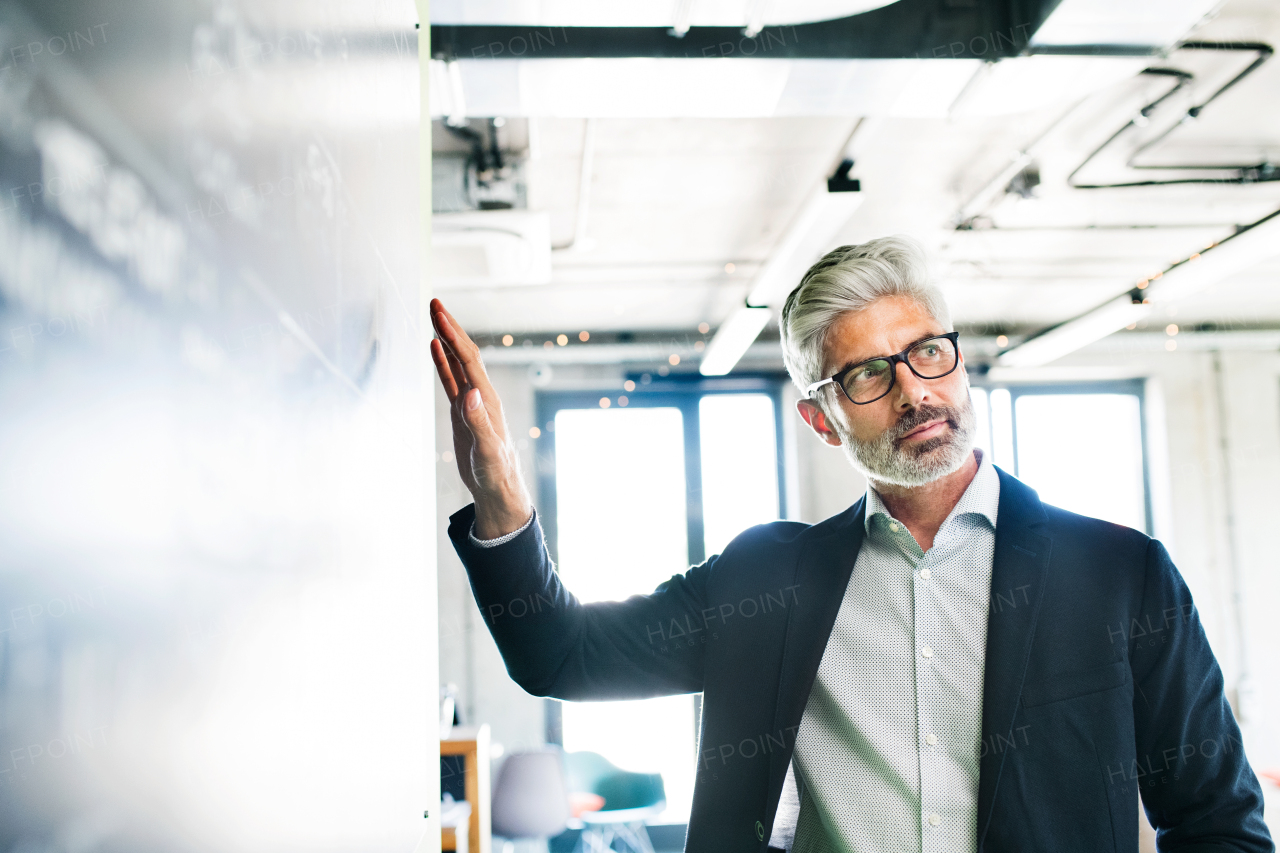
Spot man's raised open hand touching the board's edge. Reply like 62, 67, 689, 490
431, 300, 532, 539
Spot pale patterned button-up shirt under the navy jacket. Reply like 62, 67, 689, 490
791, 451, 1000, 853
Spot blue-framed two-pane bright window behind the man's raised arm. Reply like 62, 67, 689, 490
540, 381, 781, 824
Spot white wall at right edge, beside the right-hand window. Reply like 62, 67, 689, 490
1070, 350, 1280, 790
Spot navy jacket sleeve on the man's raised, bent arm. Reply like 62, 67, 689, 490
449, 503, 716, 701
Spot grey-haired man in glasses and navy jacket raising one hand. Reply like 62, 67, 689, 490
431, 237, 1274, 853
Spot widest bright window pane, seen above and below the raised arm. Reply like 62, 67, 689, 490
556, 407, 696, 822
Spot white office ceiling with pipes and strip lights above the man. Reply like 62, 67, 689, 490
440, 0, 1280, 345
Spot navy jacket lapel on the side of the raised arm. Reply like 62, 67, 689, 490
765, 496, 867, 824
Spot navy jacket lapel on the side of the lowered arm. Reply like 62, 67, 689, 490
977, 467, 1052, 850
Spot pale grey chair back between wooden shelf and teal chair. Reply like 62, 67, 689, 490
490, 748, 570, 853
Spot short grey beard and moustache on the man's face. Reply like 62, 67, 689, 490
828, 393, 977, 488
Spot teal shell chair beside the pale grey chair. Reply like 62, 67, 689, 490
564, 752, 667, 853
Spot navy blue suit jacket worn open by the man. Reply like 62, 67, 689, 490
449, 471, 1275, 853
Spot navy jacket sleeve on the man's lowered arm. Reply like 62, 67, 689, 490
1130, 539, 1275, 853
